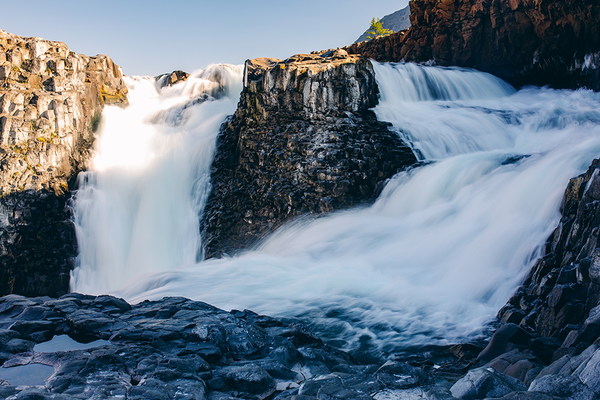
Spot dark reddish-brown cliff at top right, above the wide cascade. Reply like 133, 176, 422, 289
347, 0, 600, 90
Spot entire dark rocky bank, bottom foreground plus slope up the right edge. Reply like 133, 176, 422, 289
0, 160, 600, 400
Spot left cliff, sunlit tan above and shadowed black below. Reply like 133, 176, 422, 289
0, 31, 127, 295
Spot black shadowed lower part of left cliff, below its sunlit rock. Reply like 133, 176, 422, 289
0, 189, 77, 296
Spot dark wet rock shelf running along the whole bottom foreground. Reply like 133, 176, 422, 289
0, 293, 600, 400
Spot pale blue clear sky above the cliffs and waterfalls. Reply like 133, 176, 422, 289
0, 0, 408, 75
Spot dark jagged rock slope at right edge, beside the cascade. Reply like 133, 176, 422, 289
498, 160, 600, 358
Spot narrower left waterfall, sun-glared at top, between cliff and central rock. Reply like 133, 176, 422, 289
71, 65, 242, 293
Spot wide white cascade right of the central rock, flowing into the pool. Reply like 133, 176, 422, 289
75, 60, 600, 349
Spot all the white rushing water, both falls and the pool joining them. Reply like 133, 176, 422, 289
71, 64, 600, 351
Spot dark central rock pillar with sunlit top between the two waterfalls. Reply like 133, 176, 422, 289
202, 50, 416, 257
